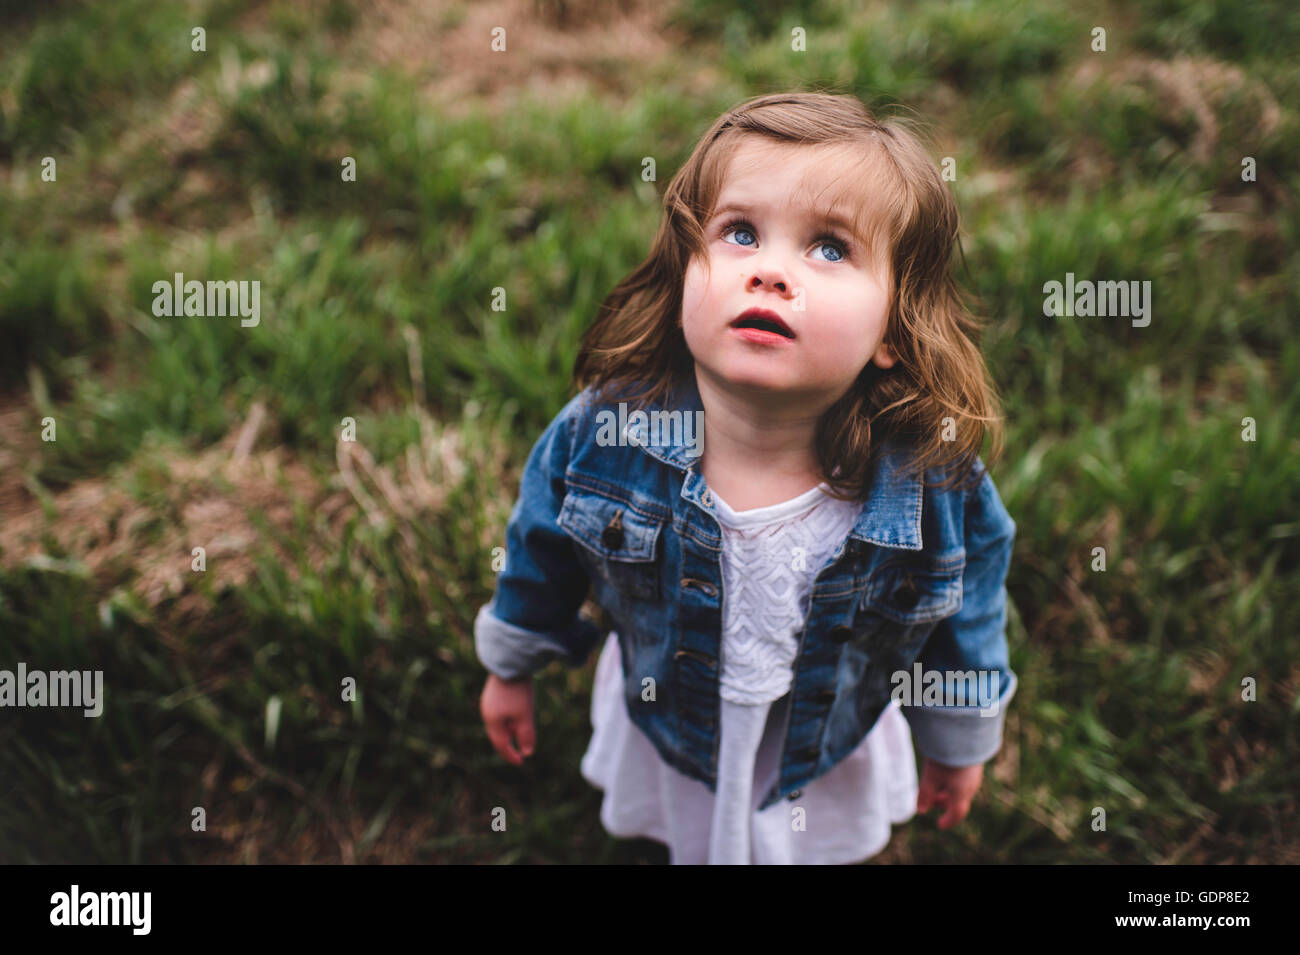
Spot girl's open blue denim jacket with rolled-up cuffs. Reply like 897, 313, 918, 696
475, 376, 1015, 809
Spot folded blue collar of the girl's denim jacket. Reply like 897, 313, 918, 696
611, 373, 924, 551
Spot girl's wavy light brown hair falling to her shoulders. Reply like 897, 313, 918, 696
573, 92, 1002, 500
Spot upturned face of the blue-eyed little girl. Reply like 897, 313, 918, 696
681, 140, 894, 407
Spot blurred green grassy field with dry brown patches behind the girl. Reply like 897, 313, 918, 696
0, 0, 1300, 863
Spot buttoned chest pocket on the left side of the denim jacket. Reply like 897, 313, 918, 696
556, 487, 668, 600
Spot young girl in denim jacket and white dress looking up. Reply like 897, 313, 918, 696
475, 92, 1015, 864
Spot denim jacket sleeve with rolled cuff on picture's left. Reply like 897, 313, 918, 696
475, 392, 601, 680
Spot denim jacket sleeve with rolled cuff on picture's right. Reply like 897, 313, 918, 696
902, 465, 1017, 767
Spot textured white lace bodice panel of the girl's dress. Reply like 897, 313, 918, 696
712, 483, 863, 706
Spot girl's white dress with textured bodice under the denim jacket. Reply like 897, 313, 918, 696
581, 483, 917, 864
